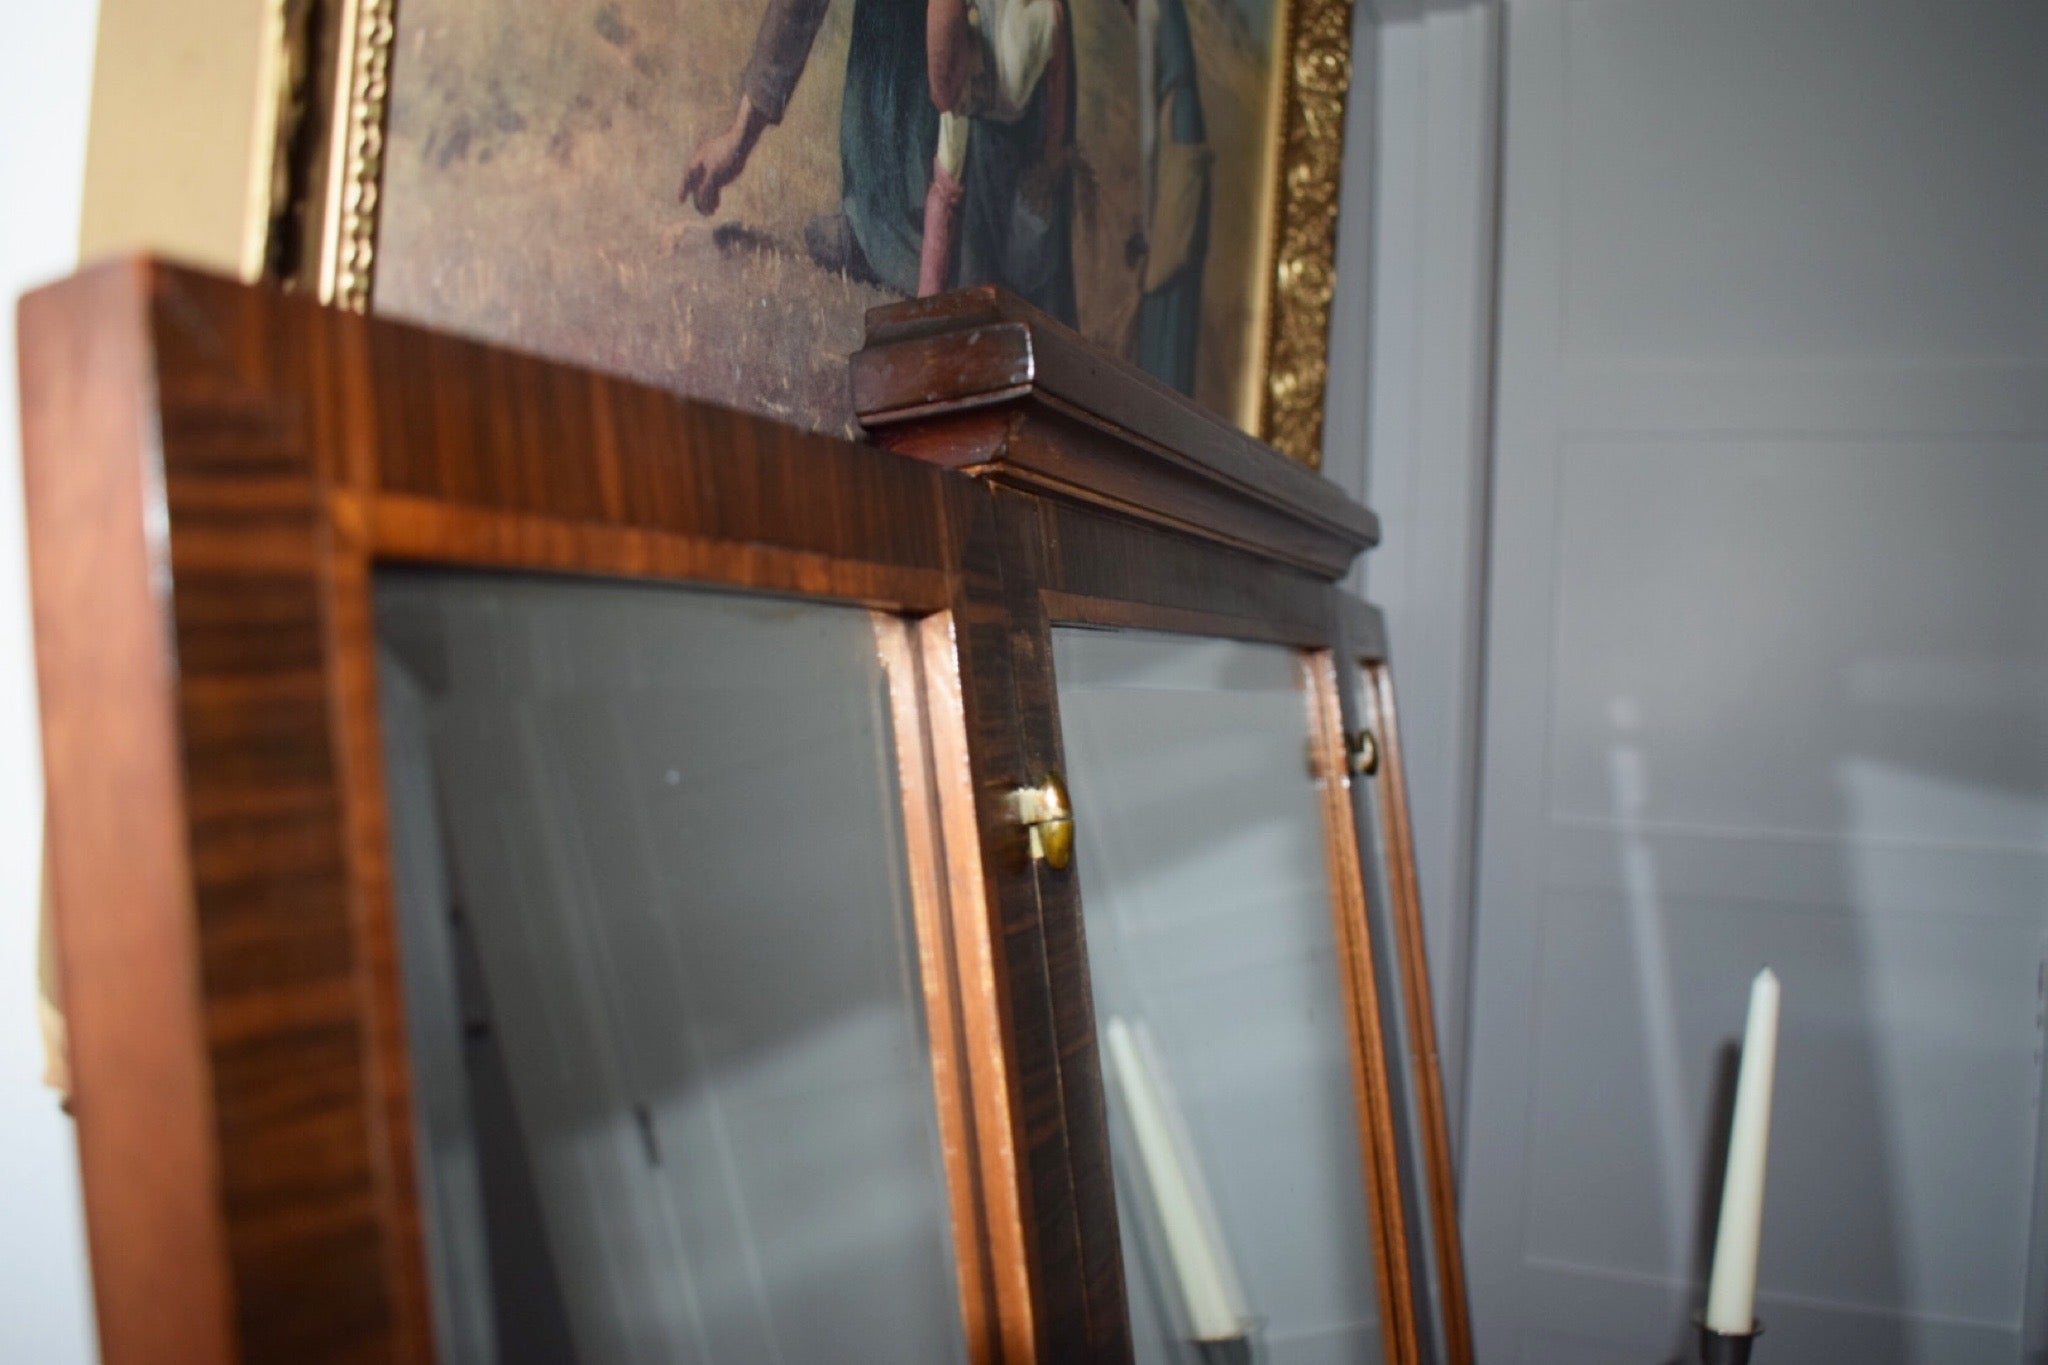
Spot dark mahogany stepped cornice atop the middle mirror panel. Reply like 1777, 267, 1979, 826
852, 284, 1380, 579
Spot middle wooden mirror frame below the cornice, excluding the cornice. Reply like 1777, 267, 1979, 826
995, 487, 1421, 1365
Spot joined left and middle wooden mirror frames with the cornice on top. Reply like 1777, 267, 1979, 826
20, 260, 1474, 1365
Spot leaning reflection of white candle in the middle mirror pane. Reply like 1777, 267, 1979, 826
1102, 1017, 1245, 1340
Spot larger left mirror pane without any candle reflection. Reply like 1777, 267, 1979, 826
377, 571, 965, 1365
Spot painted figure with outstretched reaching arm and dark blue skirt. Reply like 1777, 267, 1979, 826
682, 0, 1077, 325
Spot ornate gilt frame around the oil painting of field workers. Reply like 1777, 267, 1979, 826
280, 0, 1352, 469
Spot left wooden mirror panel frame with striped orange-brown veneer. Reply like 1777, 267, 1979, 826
20, 260, 1040, 1365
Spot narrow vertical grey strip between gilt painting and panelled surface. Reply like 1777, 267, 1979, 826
1364, 4, 1499, 1138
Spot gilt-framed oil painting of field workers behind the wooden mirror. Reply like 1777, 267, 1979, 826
297, 0, 1350, 465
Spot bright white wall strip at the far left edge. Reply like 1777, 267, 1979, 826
0, 2, 96, 1365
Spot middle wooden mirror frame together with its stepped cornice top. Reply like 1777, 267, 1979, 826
854, 291, 1423, 1365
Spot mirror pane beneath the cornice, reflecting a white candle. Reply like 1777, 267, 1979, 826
1055, 630, 1382, 1365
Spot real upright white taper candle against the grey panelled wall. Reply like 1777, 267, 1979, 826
1706, 968, 1778, 1336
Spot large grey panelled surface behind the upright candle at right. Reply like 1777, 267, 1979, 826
1464, 0, 2048, 1365
